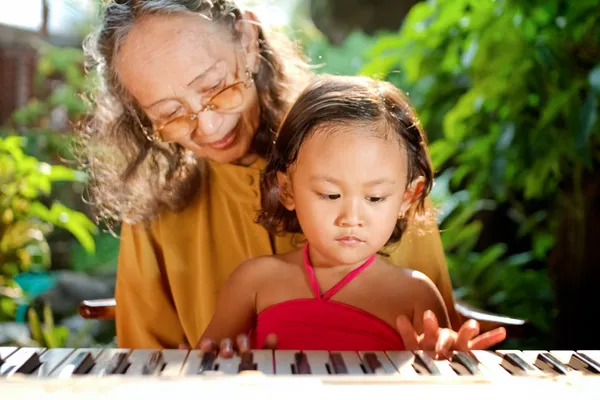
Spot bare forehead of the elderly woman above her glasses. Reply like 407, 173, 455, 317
115, 13, 235, 103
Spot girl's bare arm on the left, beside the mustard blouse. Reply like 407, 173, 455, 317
196, 259, 261, 347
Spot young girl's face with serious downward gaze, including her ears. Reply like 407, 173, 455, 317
280, 125, 422, 266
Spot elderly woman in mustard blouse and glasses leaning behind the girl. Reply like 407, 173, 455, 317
79, 0, 503, 348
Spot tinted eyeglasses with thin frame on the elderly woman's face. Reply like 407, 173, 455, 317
155, 71, 254, 143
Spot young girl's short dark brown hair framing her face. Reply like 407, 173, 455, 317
258, 75, 433, 245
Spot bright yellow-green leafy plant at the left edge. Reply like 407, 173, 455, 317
0, 136, 97, 321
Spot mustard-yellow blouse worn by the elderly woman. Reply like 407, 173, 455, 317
115, 159, 458, 348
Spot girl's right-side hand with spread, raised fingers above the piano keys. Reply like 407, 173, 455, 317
396, 311, 506, 358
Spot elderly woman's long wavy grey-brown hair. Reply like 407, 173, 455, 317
74, 0, 310, 225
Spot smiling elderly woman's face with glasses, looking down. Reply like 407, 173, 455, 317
115, 14, 260, 163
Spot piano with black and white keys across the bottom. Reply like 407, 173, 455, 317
0, 347, 600, 400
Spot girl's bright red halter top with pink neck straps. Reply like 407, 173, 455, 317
252, 245, 405, 351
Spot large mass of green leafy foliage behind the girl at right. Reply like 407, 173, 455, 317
359, 0, 600, 344
